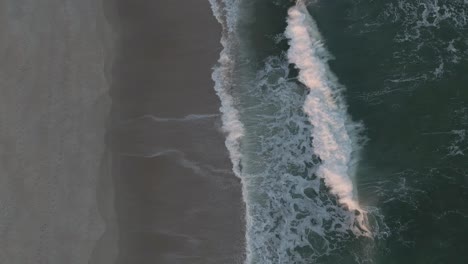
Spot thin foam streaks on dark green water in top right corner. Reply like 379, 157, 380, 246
376, 0, 468, 81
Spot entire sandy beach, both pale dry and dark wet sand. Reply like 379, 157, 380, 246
0, 0, 244, 264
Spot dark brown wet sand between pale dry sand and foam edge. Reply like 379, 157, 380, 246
109, 0, 244, 264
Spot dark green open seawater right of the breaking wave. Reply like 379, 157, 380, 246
310, 0, 468, 263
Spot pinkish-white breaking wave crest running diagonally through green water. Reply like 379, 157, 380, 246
285, 0, 371, 236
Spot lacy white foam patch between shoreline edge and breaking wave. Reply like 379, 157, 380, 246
242, 55, 381, 263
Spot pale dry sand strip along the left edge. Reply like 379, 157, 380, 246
0, 0, 117, 264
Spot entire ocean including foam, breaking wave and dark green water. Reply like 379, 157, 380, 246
211, 0, 468, 264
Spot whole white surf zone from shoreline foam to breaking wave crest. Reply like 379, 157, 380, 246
210, 0, 373, 264
